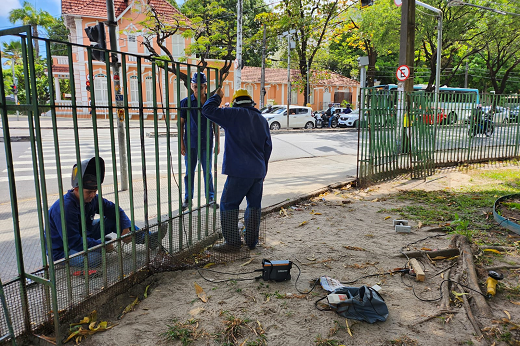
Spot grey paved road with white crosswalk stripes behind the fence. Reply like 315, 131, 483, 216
0, 118, 357, 280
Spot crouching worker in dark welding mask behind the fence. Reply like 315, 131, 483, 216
49, 157, 166, 267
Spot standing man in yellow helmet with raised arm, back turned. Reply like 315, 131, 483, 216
202, 88, 272, 252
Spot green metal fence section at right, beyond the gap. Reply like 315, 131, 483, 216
356, 88, 520, 185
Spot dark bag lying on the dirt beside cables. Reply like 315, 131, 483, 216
316, 286, 388, 323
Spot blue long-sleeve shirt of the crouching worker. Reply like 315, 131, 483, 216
49, 190, 131, 261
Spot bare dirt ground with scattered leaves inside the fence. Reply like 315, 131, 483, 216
82, 166, 520, 346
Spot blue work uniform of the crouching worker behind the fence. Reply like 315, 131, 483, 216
49, 189, 131, 267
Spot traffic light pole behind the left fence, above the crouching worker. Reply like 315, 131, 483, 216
107, 0, 128, 191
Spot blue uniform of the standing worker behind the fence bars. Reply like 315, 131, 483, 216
181, 94, 215, 201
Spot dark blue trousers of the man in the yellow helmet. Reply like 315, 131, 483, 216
220, 176, 264, 249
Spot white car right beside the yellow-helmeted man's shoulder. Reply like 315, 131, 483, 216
262, 106, 314, 130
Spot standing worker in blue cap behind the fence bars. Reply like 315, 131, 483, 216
181, 72, 220, 211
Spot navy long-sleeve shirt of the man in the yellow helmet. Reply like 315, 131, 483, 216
202, 94, 273, 178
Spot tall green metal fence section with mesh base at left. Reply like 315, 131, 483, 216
0, 26, 258, 344
